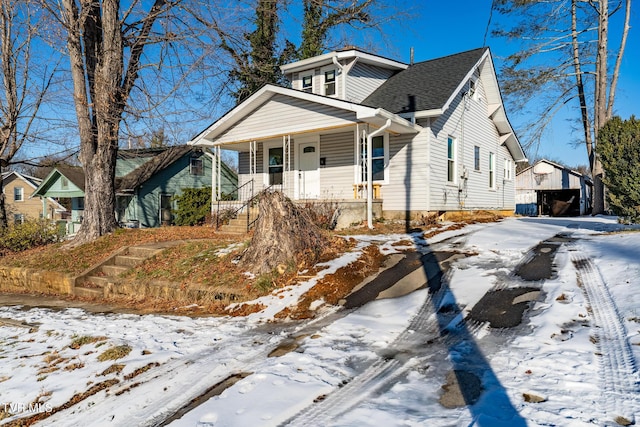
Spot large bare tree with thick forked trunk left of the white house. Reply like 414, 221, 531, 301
42, 0, 212, 244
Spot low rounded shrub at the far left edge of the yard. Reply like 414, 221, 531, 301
0, 220, 59, 252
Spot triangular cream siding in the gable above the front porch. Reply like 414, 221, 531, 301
216, 95, 355, 144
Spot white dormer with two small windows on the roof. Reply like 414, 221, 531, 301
280, 48, 408, 103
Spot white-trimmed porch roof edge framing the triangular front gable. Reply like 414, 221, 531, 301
188, 85, 422, 146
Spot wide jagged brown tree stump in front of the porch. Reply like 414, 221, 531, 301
240, 191, 328, 274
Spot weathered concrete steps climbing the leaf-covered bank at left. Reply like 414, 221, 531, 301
73, 245, 164, 298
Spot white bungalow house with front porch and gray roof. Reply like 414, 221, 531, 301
190, 48, 526, 226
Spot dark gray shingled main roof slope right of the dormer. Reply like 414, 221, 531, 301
362, 48, 488, 114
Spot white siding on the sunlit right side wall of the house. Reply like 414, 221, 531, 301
430, 80, 515, 211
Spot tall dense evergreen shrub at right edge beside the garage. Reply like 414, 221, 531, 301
596, 116, 640, 222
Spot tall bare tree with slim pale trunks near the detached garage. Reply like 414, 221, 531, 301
493, 0, 631, 214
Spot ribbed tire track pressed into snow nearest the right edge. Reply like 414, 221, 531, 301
569, 251, 640, 422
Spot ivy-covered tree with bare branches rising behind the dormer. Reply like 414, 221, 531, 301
202, 0, 400, 103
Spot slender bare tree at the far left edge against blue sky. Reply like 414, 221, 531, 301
0, 0, 56, 228
